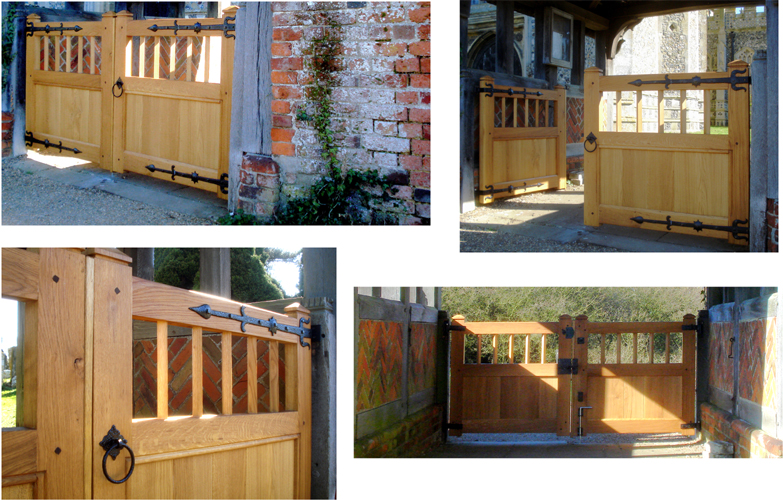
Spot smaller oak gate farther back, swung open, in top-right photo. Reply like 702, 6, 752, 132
478, 76, 566, 204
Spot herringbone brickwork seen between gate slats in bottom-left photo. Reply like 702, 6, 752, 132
133, 335, 285, 418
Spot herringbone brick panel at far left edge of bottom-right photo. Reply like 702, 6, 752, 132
356, 320, 402, 412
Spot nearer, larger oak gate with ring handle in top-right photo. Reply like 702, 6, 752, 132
584, 61, 750, 244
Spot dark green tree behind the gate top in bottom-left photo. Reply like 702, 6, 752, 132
154, 248, 284, 302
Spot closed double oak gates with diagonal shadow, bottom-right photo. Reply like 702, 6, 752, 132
448, 314, 696, 437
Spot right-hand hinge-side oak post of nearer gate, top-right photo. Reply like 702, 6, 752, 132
728, 61, 750, 245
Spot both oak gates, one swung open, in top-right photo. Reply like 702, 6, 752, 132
477, 61, 750, 244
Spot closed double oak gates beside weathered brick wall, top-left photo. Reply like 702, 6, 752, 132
27, 7, 237, 198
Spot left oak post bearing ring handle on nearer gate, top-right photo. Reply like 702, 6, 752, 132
584, 67, 603, 227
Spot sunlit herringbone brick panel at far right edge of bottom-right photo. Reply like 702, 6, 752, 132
739, 320, 777, 408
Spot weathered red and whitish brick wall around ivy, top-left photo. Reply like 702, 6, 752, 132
268, 2, 430, 224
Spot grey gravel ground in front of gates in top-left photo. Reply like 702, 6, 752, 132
2, 160, 212, 225
